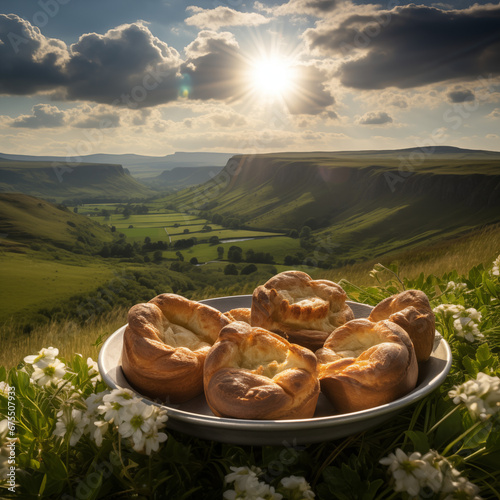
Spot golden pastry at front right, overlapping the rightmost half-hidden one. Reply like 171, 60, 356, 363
316, 318, 418, 413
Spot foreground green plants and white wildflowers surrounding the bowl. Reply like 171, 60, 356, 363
0, 257, 500, 500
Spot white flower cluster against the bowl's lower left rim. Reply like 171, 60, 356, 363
54, 389, 168, 455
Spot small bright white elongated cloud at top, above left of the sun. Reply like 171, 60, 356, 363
185, 5, 271, 30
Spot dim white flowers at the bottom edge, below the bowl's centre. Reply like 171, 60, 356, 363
223, 467, 315, 500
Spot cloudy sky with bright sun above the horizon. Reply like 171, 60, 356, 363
0, 0, 500, 156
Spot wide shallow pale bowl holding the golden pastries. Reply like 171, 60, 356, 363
98, 295, 452, 446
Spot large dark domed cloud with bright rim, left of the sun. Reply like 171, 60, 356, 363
65, 23, 181, 108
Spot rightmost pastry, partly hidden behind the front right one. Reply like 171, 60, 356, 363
368, 290, 436, 362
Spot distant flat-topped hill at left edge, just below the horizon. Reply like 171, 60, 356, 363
0, 160, 153, 204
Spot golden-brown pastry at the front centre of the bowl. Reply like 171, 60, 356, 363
204, 321, 320, 420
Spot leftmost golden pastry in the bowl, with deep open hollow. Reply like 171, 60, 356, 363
122, 293, 230, 403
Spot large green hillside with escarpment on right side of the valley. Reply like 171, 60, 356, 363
167, 147, 500, 263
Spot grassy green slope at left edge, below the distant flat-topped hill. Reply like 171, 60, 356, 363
0, 193, 113, 249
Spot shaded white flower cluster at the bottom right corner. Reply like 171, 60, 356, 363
380, 448, 480, 500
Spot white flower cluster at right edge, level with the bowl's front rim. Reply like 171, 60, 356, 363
448, 372, 500, 420
